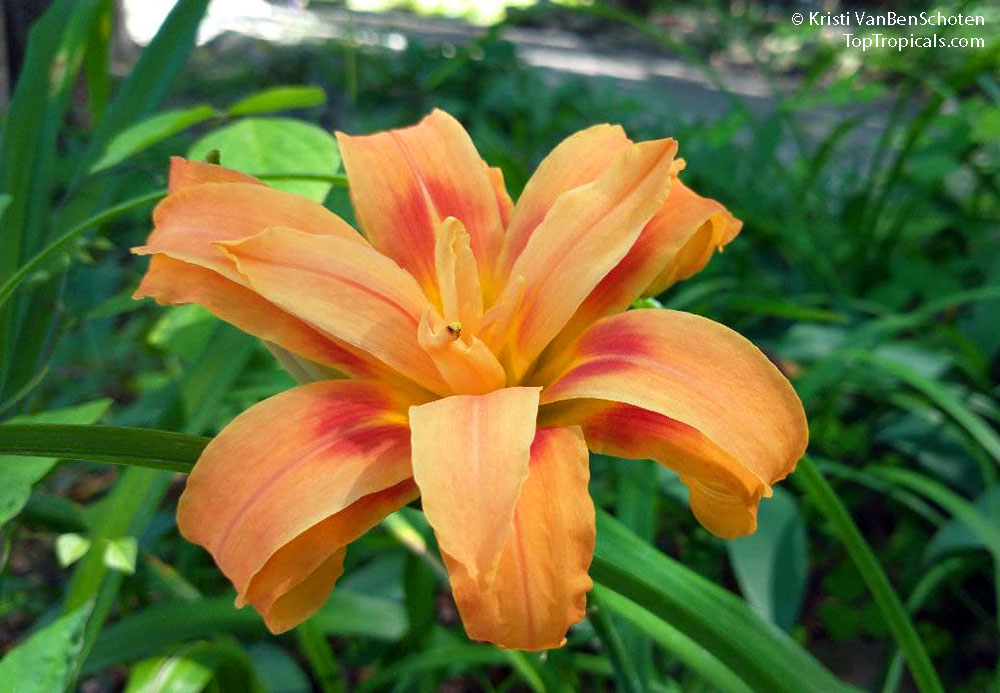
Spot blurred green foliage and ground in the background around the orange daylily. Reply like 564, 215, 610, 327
0, 0, 1000, 691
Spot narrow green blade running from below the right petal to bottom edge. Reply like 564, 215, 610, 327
793, 457, 944, 693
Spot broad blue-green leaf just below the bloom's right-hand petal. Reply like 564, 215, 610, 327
726, 489, 808, 632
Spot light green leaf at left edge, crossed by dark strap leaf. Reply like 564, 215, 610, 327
0, 399, 111, 526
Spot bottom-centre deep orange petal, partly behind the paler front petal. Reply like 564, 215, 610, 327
445, 428, 595, 650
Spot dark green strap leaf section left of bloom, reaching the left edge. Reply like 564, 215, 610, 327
0, 424, 208, 473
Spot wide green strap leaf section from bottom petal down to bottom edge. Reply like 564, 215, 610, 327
590, 511, 847, 693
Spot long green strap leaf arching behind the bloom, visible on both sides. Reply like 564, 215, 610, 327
0, 424, 860, 693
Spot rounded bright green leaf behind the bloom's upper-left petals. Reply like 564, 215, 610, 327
188, 118, 340, 202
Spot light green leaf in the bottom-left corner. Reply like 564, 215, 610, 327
0, 607, 87, 693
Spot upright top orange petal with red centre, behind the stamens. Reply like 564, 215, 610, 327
337, 110, 503, 301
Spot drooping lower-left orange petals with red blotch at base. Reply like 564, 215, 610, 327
177, 381, 413, 630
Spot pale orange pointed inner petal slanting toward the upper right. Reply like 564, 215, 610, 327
487, 139, 677, 379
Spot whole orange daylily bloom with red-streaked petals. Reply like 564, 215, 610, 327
135, 111, 807, 650
